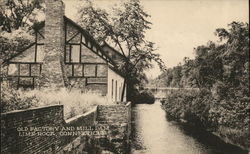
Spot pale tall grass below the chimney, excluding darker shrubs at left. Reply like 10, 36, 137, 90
30, 88, 108, 119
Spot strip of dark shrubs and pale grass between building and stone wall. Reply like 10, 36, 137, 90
1, 84, 107, 119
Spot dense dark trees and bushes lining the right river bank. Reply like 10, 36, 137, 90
158, 22, 250, 148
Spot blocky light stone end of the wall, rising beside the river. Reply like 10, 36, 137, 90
97, 102, 131, 154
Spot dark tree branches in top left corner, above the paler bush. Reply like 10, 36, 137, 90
0, 0, 45, 33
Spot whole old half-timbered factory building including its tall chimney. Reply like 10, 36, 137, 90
2, 0, 126, 101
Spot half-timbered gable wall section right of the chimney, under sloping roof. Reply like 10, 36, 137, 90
64, 21, 108, 95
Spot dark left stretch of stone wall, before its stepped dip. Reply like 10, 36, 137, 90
1, 105, 64, 153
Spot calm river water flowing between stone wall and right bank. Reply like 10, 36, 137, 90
132, 101, 248, 154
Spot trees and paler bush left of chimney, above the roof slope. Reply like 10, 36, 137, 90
0, 0, 45, 63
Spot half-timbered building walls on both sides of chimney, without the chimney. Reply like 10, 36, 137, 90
2, 18, 124, 98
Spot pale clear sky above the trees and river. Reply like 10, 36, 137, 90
64, 0, 249, 78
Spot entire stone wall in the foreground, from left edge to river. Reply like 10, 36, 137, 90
1, 103, 131, 154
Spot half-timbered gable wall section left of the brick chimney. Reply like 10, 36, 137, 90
4, 28, 44, 89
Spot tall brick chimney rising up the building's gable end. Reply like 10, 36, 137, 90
39, 0, 66, 89
